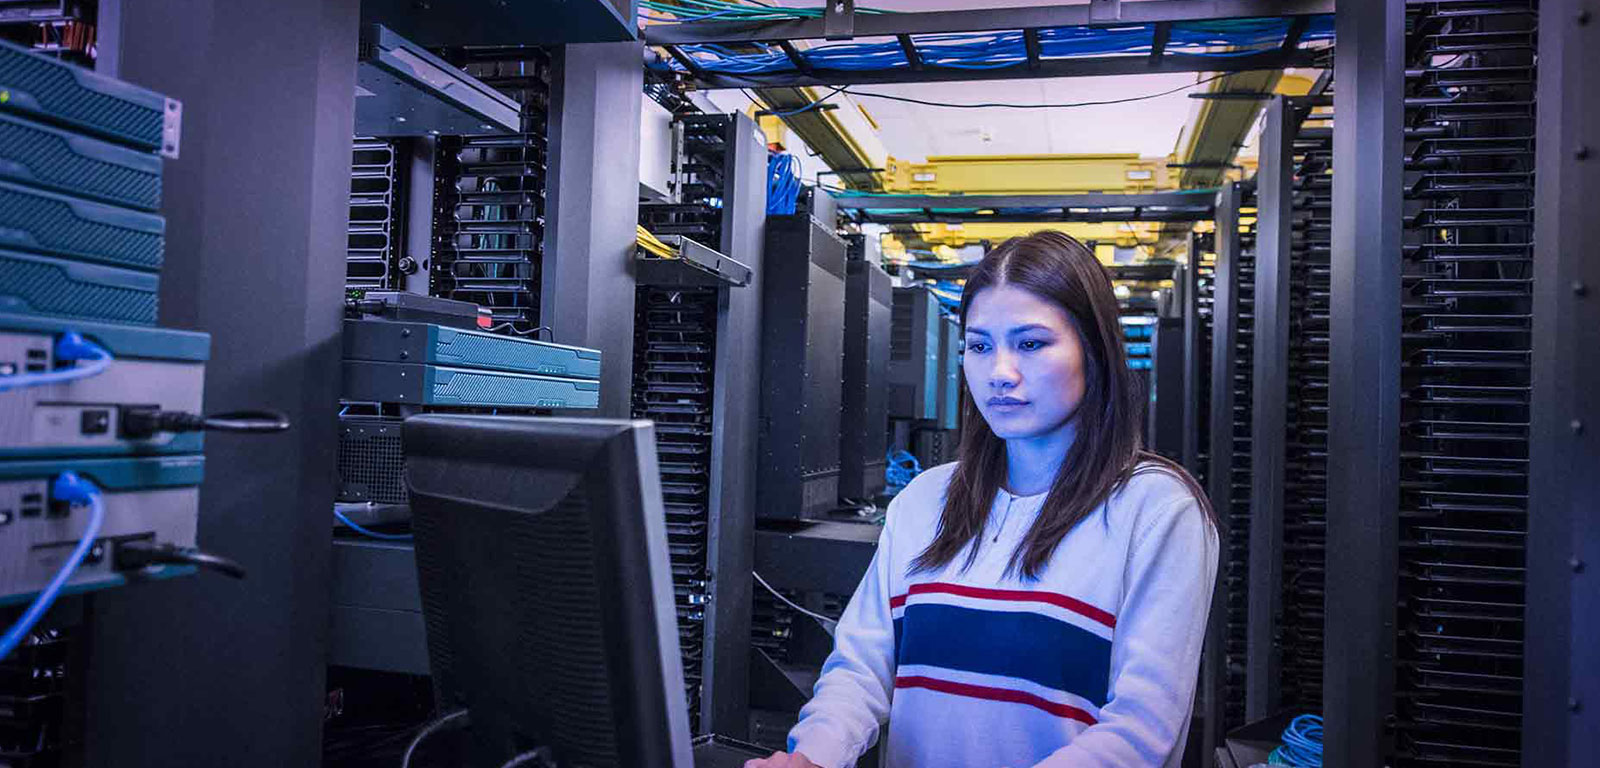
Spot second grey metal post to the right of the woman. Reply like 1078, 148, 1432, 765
1245, 96, 1296, 720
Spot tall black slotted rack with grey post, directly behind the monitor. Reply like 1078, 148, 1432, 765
632, 115, 764, 736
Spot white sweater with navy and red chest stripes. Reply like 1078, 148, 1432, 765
789, 464, 1218, 768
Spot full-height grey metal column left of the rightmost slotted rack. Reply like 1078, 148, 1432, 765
1323, 2, 1405, 765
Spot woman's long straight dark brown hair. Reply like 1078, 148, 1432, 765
912, 232, 1214, 579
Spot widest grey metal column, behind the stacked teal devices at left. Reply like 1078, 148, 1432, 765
83, 0, 360, 768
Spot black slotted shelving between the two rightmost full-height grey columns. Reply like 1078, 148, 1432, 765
1394, 2, 1538, 766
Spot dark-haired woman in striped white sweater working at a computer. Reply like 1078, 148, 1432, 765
747, 232, 1218, 768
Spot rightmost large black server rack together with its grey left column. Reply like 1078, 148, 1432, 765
1326, 0, 1561, 766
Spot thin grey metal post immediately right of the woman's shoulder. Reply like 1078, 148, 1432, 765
1203, 184, 1242, 760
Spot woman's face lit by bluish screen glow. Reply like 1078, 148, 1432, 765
962, 283, 1086, 440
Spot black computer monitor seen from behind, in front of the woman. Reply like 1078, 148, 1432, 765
403, 414, 693, 768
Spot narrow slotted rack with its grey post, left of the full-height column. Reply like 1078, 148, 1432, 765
1246, 98, 1333, 720
